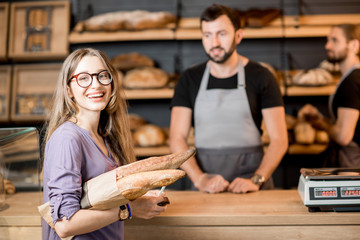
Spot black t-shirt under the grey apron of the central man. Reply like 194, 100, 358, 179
171, 61, 284, 132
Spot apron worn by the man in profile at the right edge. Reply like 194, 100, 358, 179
329, 64, 360, 168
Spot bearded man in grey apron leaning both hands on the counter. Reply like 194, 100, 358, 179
169, 4, 288, 193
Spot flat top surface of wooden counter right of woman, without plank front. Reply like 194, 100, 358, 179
129, 190, 360, 226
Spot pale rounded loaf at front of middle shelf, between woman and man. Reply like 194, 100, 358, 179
123, 67, 169, 89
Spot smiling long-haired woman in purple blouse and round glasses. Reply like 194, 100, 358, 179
43, 48, 166, 239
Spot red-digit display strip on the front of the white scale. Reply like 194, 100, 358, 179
310, 186, 360, 200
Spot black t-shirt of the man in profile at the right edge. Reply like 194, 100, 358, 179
332, 69, 360, 145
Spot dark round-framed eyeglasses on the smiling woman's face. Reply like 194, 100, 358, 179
69, 70, 112, 88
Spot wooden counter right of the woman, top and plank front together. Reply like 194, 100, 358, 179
125, 190, 360, 240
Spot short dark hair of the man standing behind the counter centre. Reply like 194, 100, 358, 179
200, 4, 240, 31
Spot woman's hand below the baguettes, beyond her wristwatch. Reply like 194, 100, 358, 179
129, 190, 167, 219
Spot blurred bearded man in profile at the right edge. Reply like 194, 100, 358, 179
298, 24, 360, 168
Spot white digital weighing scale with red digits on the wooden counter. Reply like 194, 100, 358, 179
298, 168, 360, 212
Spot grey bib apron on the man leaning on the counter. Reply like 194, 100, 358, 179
194, 57, 273, 188
